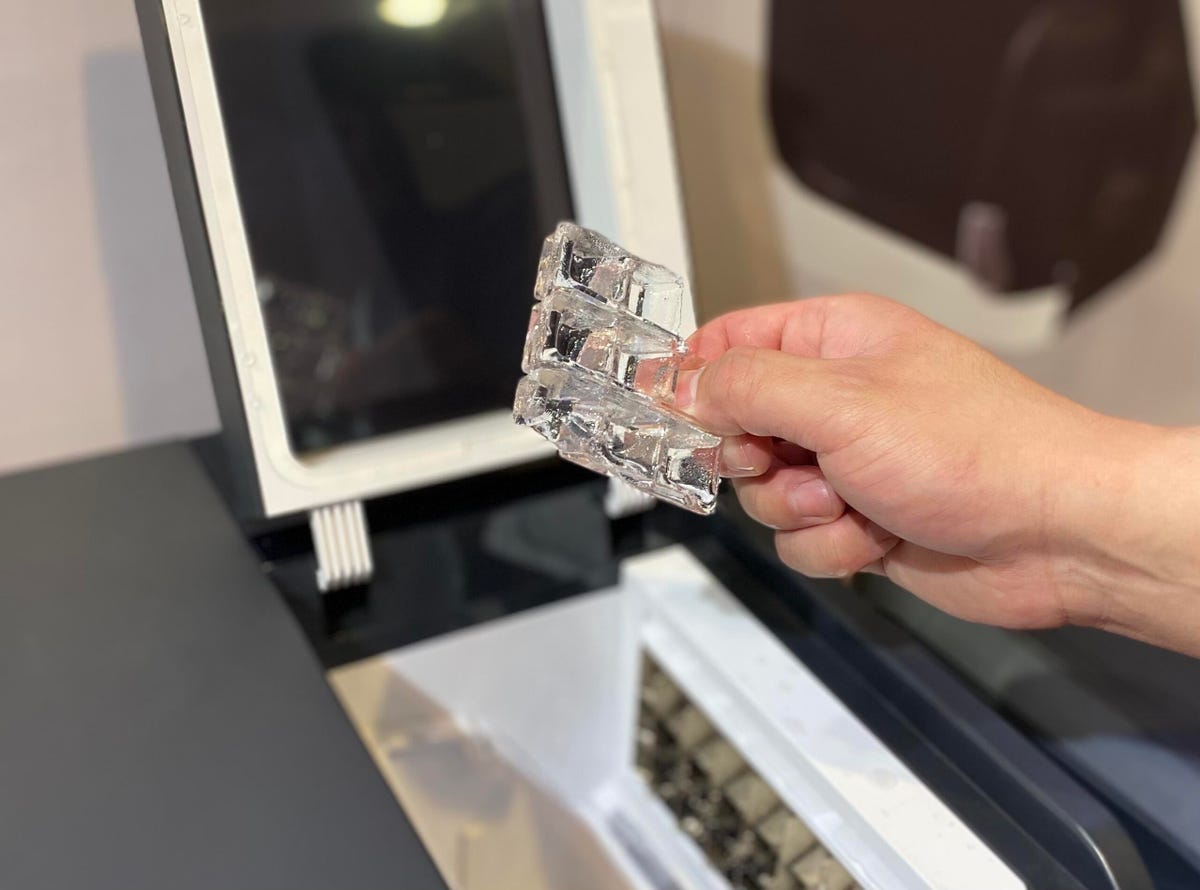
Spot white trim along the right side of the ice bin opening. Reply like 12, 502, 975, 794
622, 545, 1025, 890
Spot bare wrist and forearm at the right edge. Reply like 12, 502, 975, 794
1060, 419, 1200, 656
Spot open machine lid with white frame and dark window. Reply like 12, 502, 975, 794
140, 0, 686, 516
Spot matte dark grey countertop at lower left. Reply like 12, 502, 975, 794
0, 444, 444, 890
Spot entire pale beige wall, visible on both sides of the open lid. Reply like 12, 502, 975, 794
0, 0, 1200, 482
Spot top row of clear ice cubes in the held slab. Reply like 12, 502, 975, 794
534, 222, 684, 332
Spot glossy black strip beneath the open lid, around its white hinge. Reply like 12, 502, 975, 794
261, 459, 619, 668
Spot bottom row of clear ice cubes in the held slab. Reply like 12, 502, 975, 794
512, 366, 721, 513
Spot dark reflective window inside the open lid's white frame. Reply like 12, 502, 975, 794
203, 0, 570, 451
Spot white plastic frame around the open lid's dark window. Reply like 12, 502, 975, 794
162, 0, 694, 516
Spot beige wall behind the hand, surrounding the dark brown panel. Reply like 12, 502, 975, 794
655, 0, 1200, 423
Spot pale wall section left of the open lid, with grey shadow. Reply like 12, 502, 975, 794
0, 0, 216, 471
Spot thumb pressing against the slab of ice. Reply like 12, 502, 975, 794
676, 347, 846, 452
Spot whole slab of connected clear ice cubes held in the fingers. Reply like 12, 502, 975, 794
512, 223, 721, 515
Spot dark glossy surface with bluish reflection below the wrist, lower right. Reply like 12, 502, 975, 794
863, 578, 1200, 890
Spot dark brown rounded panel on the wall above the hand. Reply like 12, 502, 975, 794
769, 0, 1195, 305
